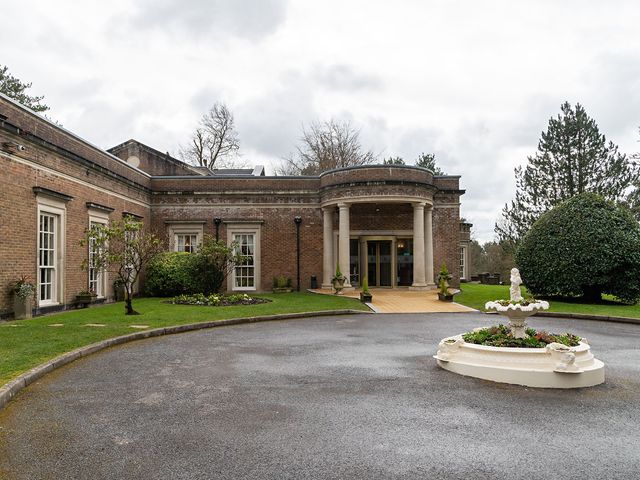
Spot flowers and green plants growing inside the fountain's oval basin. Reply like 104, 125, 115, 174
462, 325, 581, 348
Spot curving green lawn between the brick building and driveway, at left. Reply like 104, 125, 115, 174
0, 293, 368, 386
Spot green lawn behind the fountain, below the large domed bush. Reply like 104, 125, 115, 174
455, 283, 640, 318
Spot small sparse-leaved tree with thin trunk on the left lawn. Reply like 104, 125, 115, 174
80, 216, 162, 315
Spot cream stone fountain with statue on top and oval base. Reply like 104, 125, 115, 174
434, 268, 604, 388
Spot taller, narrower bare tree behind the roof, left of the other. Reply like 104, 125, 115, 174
178, 102, 240, 169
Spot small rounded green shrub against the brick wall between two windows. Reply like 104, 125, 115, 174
145, 252, 201, 297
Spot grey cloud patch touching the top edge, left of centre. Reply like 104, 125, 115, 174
129, 0, 287, 41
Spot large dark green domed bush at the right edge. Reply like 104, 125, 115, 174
515, 193, 640, 303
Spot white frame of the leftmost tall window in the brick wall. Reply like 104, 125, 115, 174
36, 199, 67, 307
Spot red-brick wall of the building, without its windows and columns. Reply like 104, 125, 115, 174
0, 100, 461, 316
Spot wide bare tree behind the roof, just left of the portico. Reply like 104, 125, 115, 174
277, 120, 376, 175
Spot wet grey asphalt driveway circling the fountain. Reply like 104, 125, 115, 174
0, 314, 640, 479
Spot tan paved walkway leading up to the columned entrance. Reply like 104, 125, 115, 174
310, 288, 475, 313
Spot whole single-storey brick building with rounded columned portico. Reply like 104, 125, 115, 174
0, 94, 465, 318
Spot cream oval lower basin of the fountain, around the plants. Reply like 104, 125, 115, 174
434, 335, 604, 388
